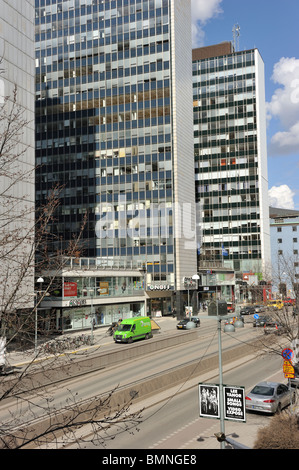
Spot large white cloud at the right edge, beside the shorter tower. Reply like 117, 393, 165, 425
267, 57, 299, 155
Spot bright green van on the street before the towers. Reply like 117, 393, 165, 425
113, 317, 153, 343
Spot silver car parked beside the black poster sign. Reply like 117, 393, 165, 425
245, 382, 295, 414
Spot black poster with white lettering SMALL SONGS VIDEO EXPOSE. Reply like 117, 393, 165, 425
223, 386, 246, 421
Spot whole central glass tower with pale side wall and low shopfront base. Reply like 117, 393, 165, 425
35, 0, 196, 330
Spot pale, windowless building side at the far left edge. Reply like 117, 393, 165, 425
0, 0, 35, 316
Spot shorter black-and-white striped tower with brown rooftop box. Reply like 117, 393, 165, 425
193, 42, 271, 294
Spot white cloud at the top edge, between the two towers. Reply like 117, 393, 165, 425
191, 0, 222, 47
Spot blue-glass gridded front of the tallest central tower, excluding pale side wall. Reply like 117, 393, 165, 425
35, 0, 174, 282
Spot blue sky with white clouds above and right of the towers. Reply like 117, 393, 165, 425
191, 0, 299, 210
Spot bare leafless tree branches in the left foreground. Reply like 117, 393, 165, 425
0, 78, 144, 449
